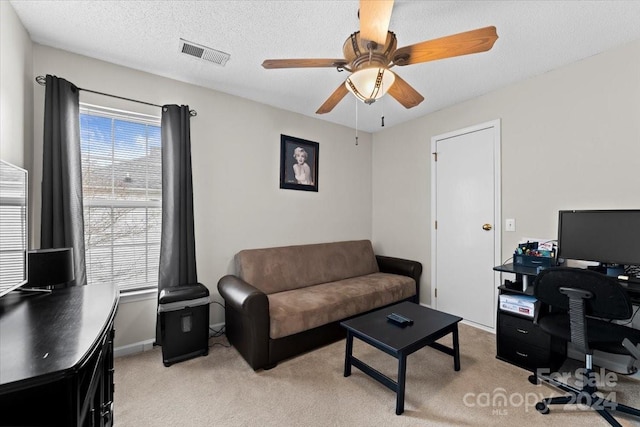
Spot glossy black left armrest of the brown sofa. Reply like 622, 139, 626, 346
218, 275, 270, 370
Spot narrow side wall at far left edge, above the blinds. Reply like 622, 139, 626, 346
0, 1, 33, 168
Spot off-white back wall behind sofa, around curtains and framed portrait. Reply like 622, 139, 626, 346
32, 44, 372, 347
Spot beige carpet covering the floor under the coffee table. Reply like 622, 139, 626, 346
115, 325, 640, 427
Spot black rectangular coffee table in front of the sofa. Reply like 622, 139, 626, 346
340, 302, 462, 415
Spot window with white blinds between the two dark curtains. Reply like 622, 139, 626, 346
80, 104, 162, 291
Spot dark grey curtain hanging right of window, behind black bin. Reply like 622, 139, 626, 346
156, 105, 198, 345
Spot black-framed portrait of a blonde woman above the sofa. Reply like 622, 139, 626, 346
280, 135, 319, 192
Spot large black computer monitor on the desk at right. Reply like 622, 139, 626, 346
558, 209, 640, 265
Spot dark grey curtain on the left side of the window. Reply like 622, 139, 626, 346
40, 75, 87, 285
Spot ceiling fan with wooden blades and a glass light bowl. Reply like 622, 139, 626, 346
262, 0, 498, 114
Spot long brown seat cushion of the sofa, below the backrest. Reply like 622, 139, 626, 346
268, 273, 416, 339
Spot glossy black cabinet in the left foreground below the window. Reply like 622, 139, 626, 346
0, 285, 118, 427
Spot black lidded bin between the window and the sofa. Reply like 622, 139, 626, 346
158, 283, 210, 366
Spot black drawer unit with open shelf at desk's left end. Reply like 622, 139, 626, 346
494, 264, 566, 371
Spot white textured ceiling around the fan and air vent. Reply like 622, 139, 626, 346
11, 0, 640, 132
